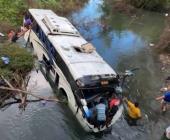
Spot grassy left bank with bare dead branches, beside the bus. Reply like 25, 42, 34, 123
0, 42, 34, 108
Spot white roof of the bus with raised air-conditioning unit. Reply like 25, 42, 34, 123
29, 9, 116, 80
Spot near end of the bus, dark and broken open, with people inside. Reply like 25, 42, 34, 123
75, 75, 122, 132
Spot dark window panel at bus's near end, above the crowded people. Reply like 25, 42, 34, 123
77, 75, 119, 101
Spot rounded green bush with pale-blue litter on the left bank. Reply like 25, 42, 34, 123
0, 44, 34, 79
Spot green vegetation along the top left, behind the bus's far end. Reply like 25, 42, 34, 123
0, 0, 87, 26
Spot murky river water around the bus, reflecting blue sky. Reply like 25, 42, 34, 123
0, 0, 170, 140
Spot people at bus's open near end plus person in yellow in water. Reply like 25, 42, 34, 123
83, 93, 141, 130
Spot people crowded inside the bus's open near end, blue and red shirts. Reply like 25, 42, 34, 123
83, 97, 120, 130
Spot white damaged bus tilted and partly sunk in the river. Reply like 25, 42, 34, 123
25, 9, 123, 132
